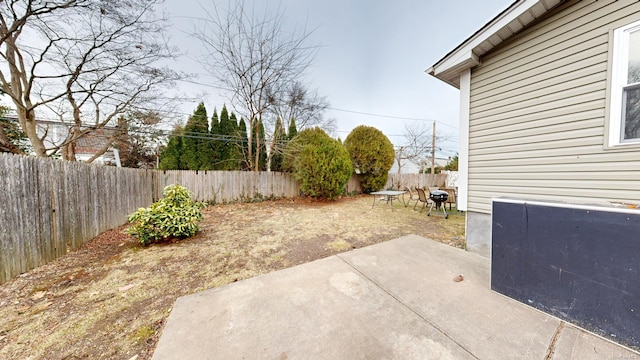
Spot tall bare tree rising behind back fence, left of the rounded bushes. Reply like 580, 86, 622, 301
193, 1, 317, 170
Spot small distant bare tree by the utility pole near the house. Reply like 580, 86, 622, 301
395, 123, 447, 174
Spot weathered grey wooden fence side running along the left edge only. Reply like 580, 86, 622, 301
0, 154, 152, 283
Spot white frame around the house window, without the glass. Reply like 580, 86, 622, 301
608, 21, 640, 146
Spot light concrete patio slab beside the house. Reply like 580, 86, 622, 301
153, 235, 640, 360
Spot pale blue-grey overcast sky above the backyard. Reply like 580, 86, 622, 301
165, 0, 513, 157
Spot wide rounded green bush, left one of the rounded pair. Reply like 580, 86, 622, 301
285, 128, 353, 199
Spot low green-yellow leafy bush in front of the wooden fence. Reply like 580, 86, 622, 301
126, 185, 205, 245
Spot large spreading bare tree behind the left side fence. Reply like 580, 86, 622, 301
0, 0, 180, 161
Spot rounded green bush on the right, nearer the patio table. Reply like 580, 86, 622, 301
344, 125, 395, 193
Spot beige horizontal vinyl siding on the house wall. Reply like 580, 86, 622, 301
468, 0, 640, 213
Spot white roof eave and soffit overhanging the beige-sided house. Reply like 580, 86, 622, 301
426, 0, 565, 88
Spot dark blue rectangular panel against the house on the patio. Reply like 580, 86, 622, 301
491, 201, 640, 349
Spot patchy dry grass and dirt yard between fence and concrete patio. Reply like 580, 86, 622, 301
0, 196, 464, 360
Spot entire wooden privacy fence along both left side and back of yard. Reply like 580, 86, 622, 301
0, 153, 446, 284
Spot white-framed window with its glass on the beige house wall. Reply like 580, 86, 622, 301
609, 21, 640, 145
